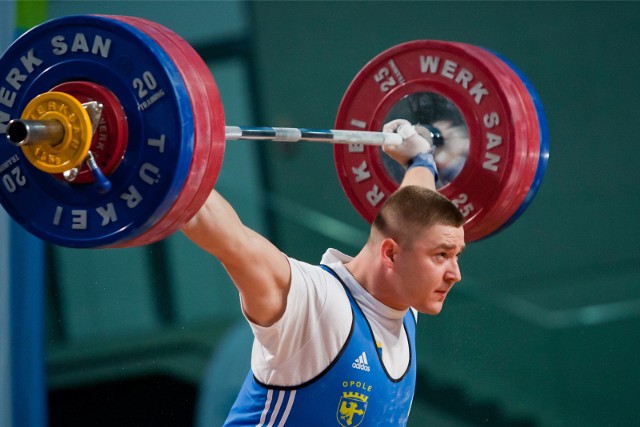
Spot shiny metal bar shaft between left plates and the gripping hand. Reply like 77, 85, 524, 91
225, 126, 402, 145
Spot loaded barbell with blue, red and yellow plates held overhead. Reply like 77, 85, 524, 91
0, 15, 549, 248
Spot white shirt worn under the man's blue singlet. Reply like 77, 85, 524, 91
242, 249, 409, 386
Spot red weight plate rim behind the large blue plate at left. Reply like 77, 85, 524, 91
113, 16, 225, 247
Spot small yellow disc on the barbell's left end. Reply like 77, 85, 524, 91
21, 92, 93, 173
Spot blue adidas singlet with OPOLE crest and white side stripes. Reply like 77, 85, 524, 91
225, 265, 416, 427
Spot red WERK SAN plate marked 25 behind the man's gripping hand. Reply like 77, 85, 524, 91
334, 40, 531, 242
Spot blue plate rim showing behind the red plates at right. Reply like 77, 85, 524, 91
484, 48, 549, 237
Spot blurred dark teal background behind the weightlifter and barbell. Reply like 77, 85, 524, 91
0, 0, 640, 427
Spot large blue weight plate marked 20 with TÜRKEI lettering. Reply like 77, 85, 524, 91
0, 16, 194, 248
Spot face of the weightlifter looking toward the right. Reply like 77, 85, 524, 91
395, 224, 465, 314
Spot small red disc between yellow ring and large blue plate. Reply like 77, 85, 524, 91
51, 81, 128, 184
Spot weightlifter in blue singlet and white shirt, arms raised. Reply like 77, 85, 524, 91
182, 120, 465, 427
